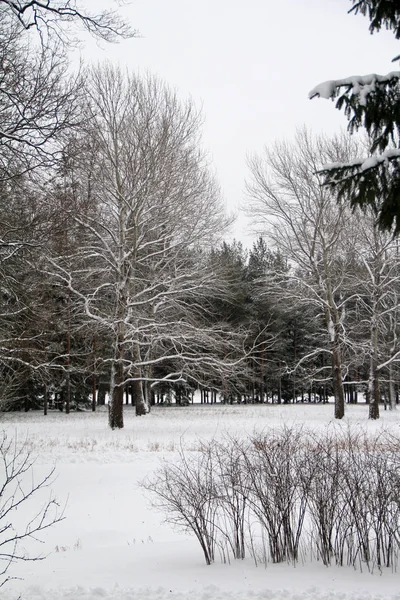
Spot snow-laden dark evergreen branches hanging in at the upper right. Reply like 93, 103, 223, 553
309, 0, 400, 234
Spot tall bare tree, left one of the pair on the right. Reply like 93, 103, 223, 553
247, 131, 358, 419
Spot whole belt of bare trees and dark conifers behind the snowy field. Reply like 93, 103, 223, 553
0, 2, 400, 428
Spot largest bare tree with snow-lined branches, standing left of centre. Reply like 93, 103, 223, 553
46, 65, 234, 427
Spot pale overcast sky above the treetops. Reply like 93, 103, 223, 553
83, 0, 399, 243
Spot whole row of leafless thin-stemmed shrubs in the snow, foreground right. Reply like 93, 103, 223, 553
144, 427, 400, 570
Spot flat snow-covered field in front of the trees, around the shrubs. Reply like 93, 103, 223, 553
0, 405, 400, 600
